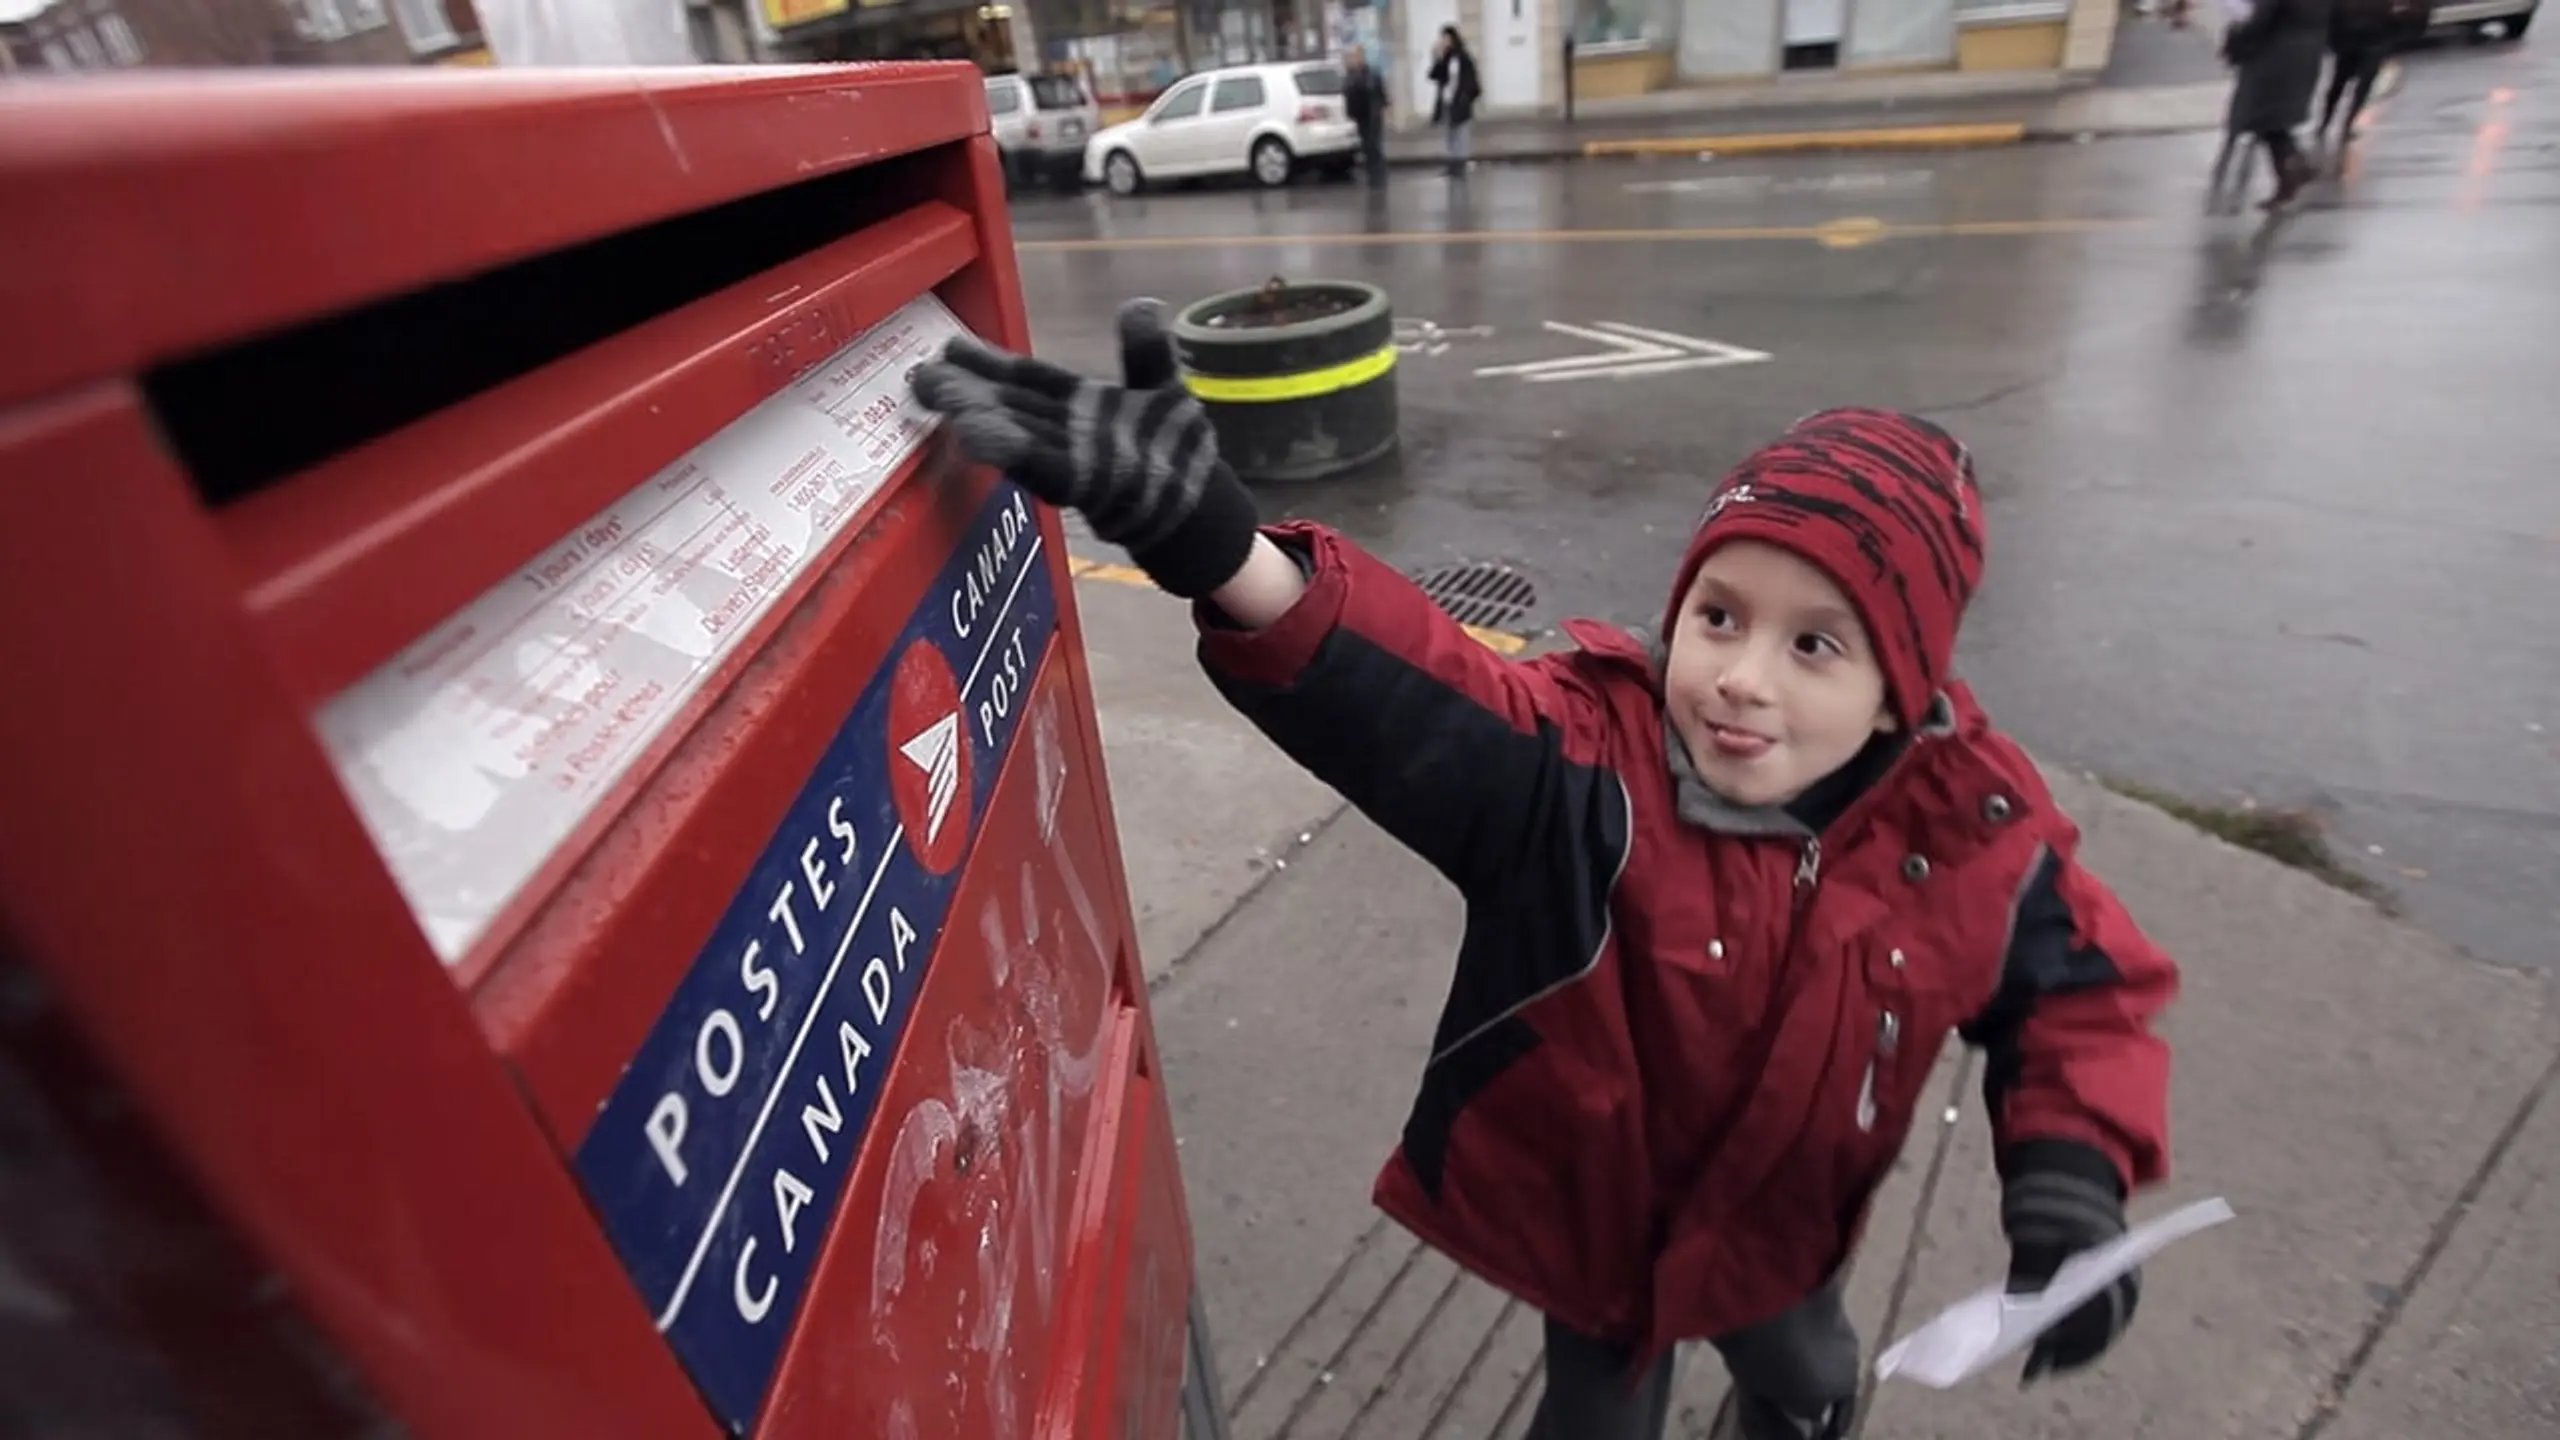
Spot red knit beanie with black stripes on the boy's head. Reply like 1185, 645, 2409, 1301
1661, 410, 1981, 725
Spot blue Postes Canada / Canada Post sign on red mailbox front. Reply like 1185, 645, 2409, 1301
576, 484, 1057, 1435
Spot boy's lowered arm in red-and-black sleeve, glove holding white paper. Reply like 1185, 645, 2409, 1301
1964, 830, 2179, 1381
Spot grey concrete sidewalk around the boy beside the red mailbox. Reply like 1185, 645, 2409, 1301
1078, 571, 2560, 1440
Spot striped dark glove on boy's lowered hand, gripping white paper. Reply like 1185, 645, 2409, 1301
1999, 1140, 2143, 1384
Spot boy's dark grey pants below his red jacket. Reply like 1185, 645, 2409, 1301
1528, 1281, 1859, 1440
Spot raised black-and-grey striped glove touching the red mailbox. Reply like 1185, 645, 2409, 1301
914, 300, 1260, 600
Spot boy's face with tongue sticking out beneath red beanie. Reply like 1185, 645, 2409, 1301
1661, 541, 1894, 805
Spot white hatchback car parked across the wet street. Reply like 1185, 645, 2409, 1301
1085, 59, 1359, 195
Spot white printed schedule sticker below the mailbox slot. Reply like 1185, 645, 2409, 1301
317, 295, 963, 966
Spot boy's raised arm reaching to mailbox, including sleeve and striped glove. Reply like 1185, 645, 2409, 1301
914, 302, 1628, 891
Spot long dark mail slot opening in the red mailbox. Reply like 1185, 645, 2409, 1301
143, 151, 967, 507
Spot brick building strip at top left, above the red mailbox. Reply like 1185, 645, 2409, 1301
0, 0, 481, 72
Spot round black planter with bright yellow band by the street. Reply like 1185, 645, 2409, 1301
1172, 279, 1398, 482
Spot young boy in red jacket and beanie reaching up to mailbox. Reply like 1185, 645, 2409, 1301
914, 302, 2179, 1440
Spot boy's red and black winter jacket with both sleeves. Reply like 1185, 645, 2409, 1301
1201, 525, 2179, 1353
